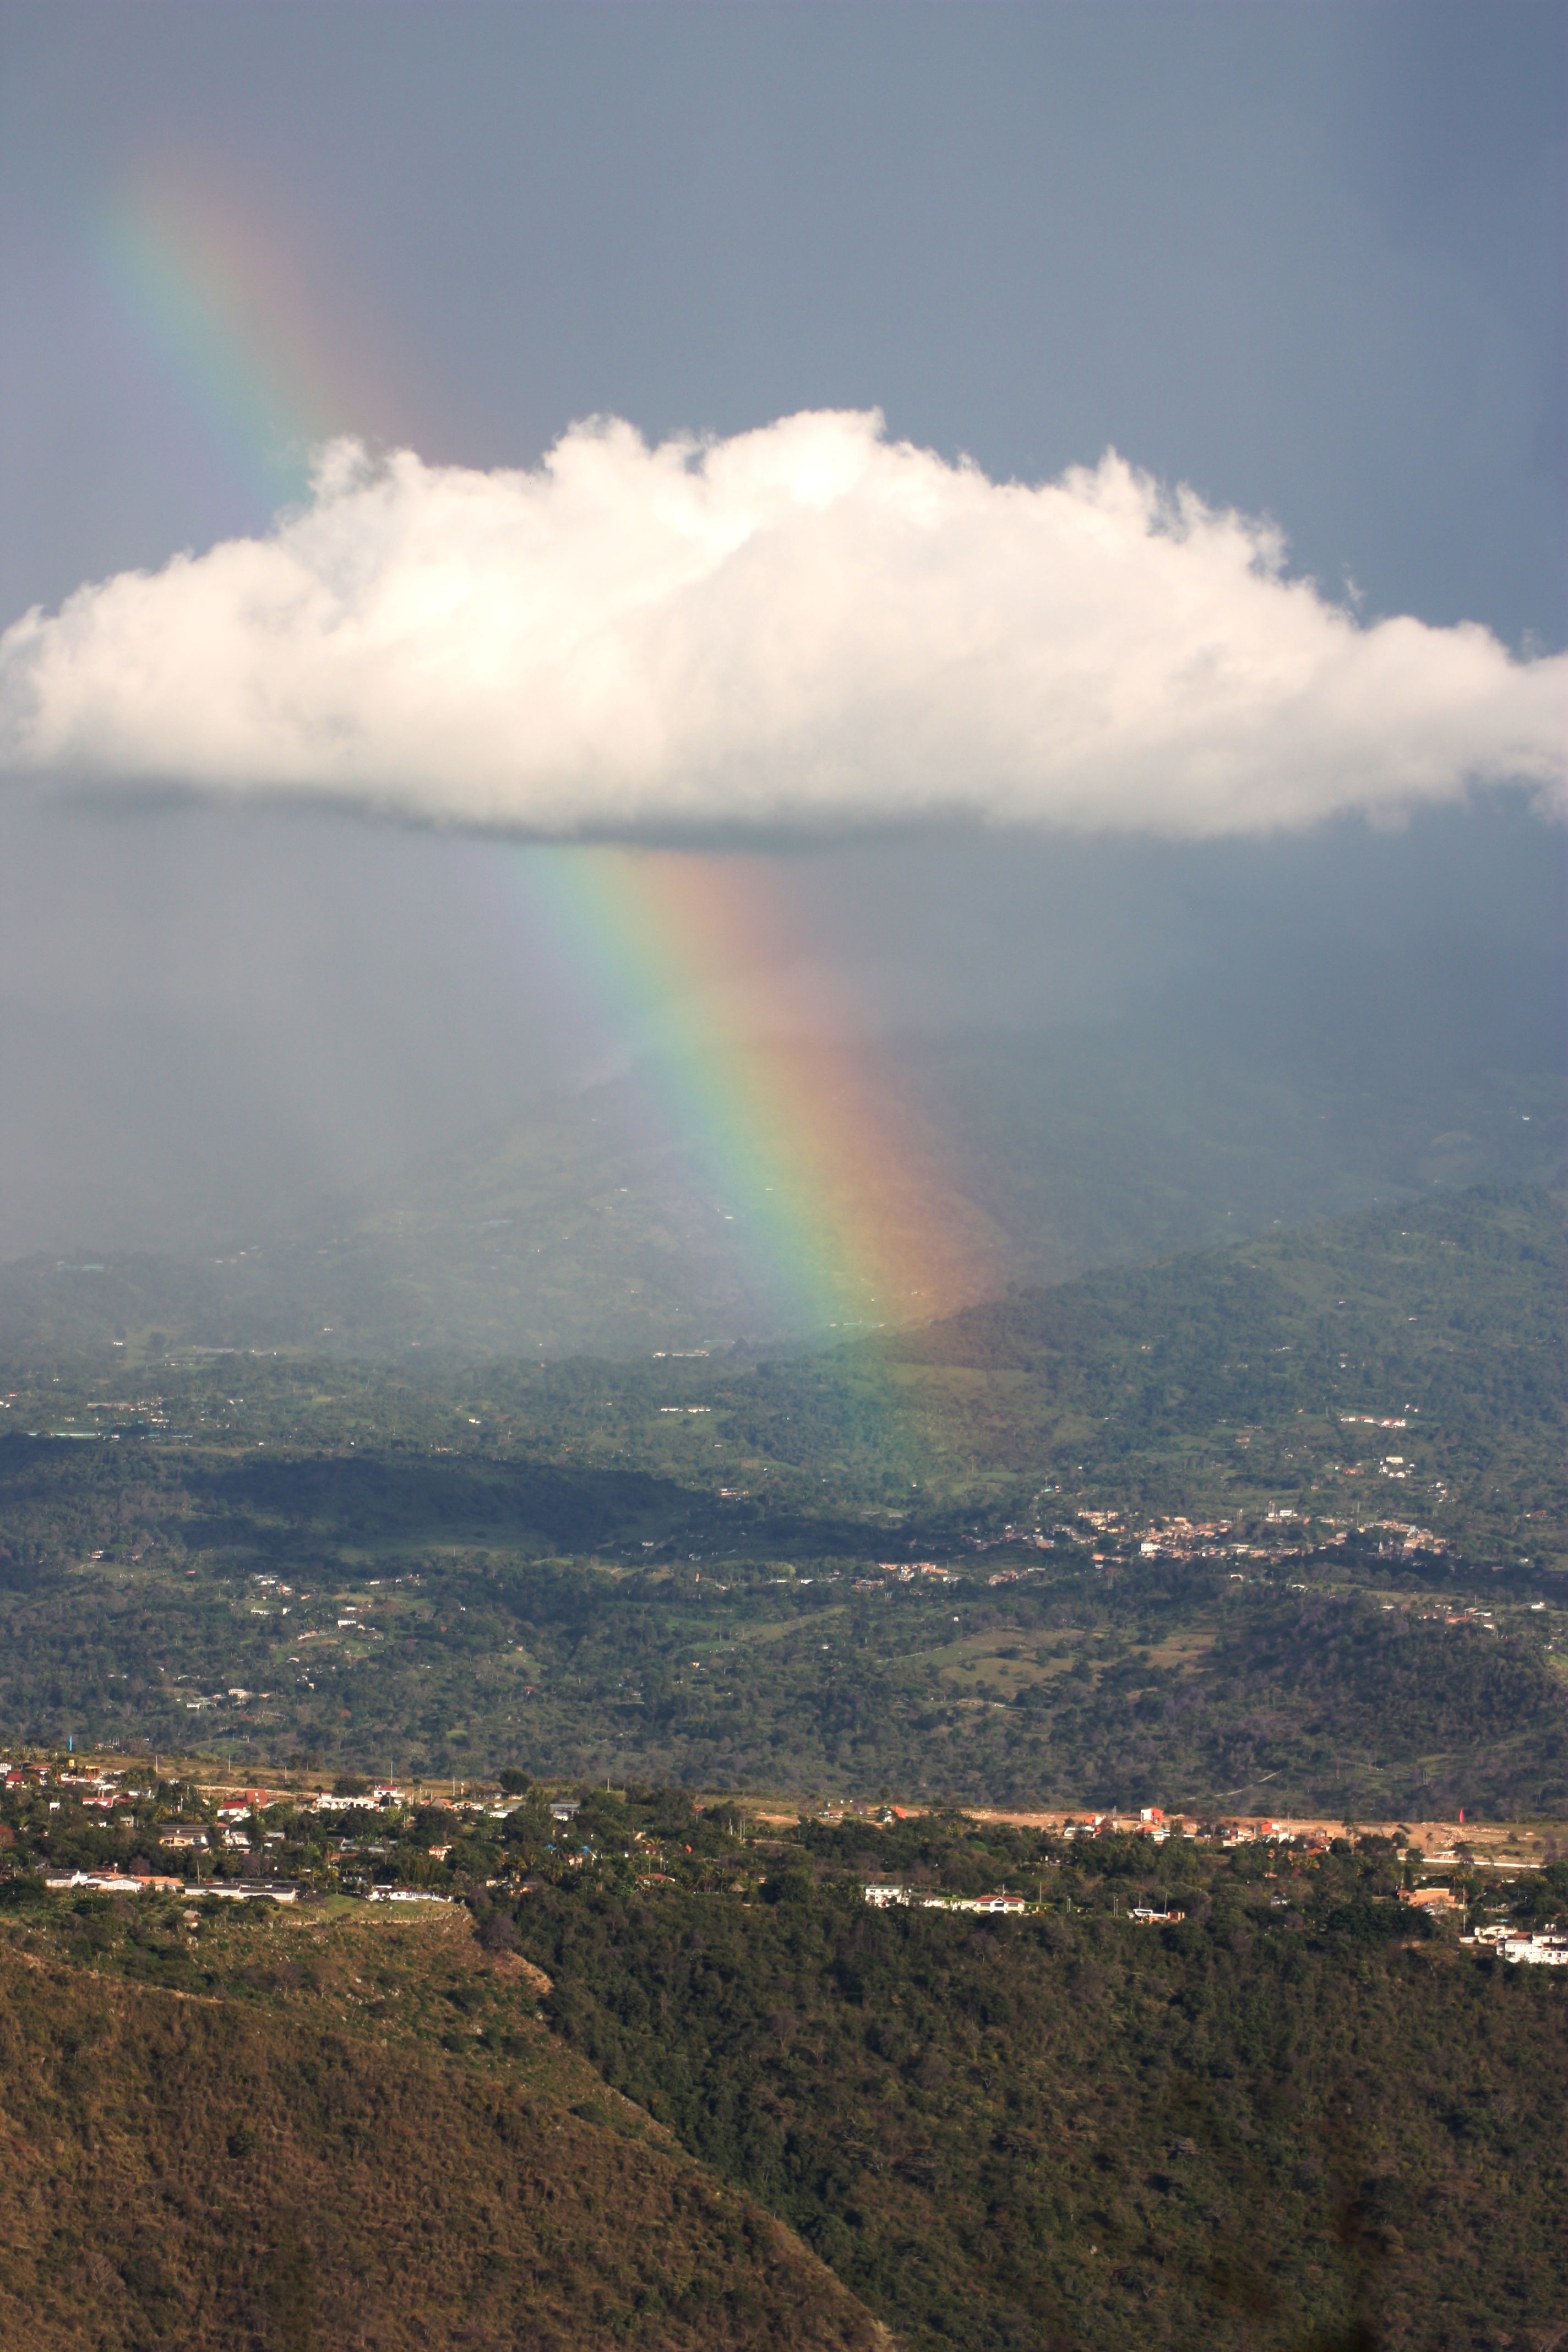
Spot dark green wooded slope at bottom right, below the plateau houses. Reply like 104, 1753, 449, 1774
517, 1830, 1568, 2352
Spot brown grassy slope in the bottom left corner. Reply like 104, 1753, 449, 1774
0, 1954, 889, 2352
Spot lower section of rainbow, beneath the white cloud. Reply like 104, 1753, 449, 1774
505, 845, 992, 1329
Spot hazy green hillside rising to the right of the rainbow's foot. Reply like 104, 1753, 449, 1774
869, 1193, 1568, 1564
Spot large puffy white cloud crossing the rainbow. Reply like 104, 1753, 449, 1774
0, 414, 1566, 835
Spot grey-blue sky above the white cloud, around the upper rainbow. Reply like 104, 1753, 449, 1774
0, 0, 1568, 645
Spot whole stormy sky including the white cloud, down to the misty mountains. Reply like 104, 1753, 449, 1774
0, 0, 1568, 1289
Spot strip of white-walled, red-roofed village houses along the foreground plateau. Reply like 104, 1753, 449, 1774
0, 1757, 1568, 1966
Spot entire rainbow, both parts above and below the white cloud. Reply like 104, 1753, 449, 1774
99, 166, 994, 1329
